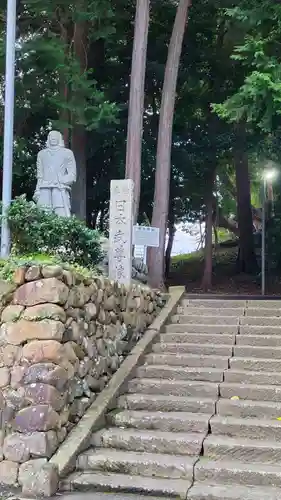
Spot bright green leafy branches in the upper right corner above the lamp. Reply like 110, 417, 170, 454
213, 0, 281, 132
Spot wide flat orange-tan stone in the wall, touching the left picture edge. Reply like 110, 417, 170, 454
0, 319, 64, 345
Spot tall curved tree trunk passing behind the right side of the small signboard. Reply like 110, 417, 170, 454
148, 0, 191, 288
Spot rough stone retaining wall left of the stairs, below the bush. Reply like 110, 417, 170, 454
0, 266, 163, 486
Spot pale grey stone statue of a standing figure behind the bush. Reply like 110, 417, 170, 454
33, 130, 76, 217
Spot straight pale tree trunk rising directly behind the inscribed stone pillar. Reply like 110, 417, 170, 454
126, 0, 149, 222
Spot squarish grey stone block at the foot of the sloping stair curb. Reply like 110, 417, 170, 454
21, 462, 59, 497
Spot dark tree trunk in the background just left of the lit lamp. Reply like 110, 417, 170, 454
234, 124, 257, 274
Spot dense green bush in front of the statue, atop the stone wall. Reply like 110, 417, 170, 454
4, 196, 102, 268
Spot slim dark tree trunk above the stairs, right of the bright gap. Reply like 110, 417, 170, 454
202, 171, 215, 292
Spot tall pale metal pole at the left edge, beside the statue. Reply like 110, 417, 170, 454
1, 0, 17, 258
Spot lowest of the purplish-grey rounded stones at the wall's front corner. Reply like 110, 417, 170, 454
13, 405, 60, 432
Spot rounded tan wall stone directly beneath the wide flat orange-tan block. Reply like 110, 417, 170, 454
22, 340, 65, 364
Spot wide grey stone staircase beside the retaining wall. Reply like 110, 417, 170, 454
62, 299, 281, 500
